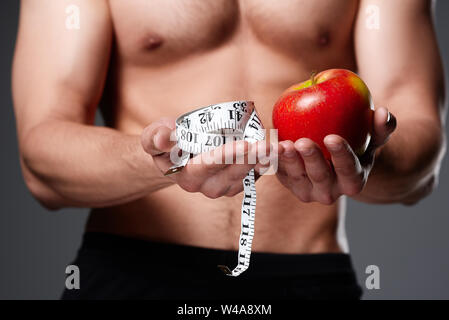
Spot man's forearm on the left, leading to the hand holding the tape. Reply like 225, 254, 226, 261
21, 121, 172, 208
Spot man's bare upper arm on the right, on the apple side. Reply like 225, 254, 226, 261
355, 0, 444, 121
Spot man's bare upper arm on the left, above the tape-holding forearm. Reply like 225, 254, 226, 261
12, 0, 112, 140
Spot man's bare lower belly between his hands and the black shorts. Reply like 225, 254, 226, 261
87, 176, 341, 253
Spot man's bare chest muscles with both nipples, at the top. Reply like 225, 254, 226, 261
109, 0, 358, 65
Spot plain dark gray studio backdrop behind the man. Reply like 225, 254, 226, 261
0, 0, 449, 299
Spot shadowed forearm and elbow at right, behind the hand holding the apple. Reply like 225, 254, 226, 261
353, 117, 445, 203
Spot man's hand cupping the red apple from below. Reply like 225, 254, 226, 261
277, 108, 396, 205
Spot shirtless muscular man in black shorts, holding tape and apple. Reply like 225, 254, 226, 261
13, 0, 445, 298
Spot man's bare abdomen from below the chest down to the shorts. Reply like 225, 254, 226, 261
87, 33, 352, 253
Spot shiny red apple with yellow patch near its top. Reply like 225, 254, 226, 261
273, 69, 374, 160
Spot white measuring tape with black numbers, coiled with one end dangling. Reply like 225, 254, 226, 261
165, 101, 265, 277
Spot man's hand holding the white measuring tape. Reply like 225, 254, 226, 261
141, 118, 270, 199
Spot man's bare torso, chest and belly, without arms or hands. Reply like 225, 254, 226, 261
87, 0, 358, 253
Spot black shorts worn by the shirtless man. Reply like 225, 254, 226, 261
62, 233, 362, 300
